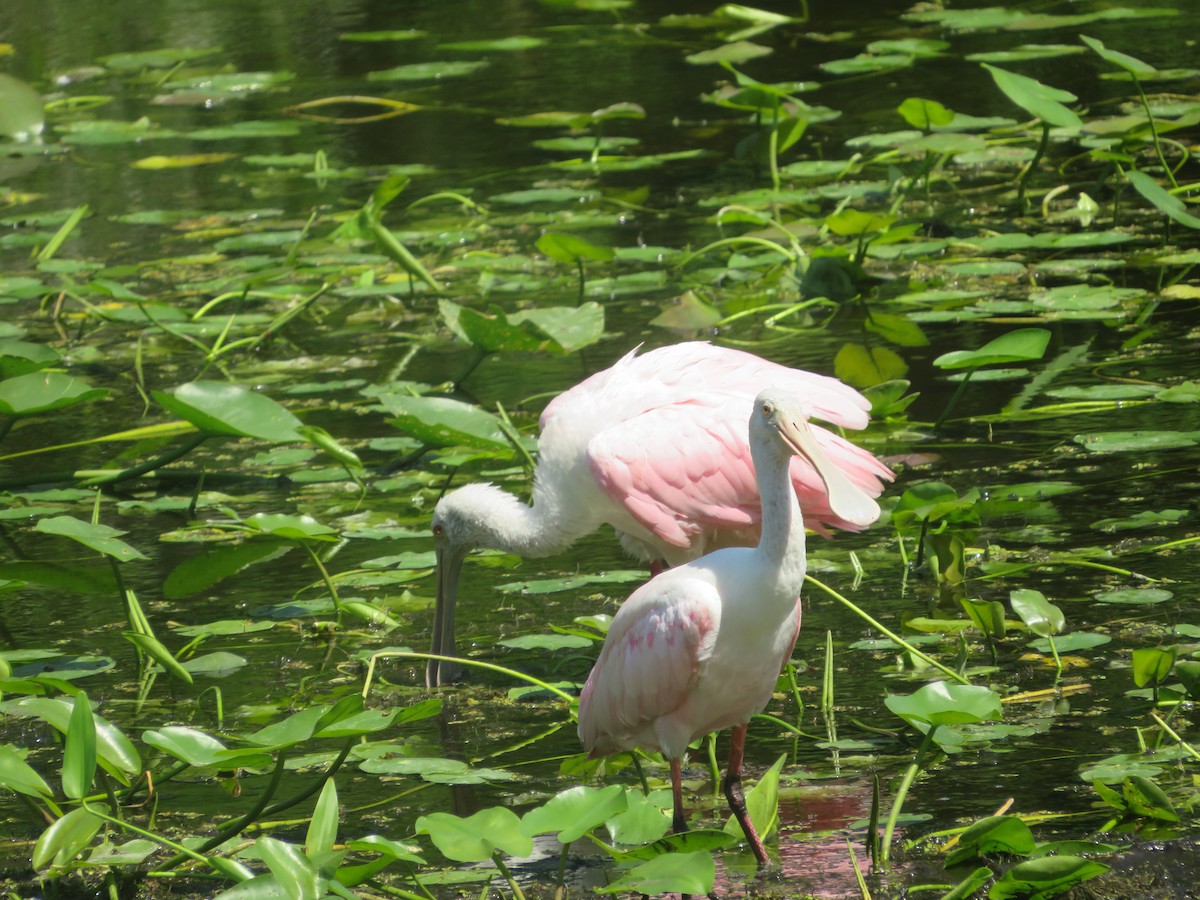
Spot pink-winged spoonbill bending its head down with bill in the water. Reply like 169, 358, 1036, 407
426, 341, 892, 688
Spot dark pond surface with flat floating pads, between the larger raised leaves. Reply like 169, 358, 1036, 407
0, 0, 1200, 898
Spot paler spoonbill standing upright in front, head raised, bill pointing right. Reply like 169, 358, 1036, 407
580, 390, 878, 865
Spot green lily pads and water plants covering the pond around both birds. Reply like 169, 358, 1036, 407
0, 0, 1200, 898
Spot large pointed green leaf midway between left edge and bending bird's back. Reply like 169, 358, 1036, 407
152, 382, 304, 443
